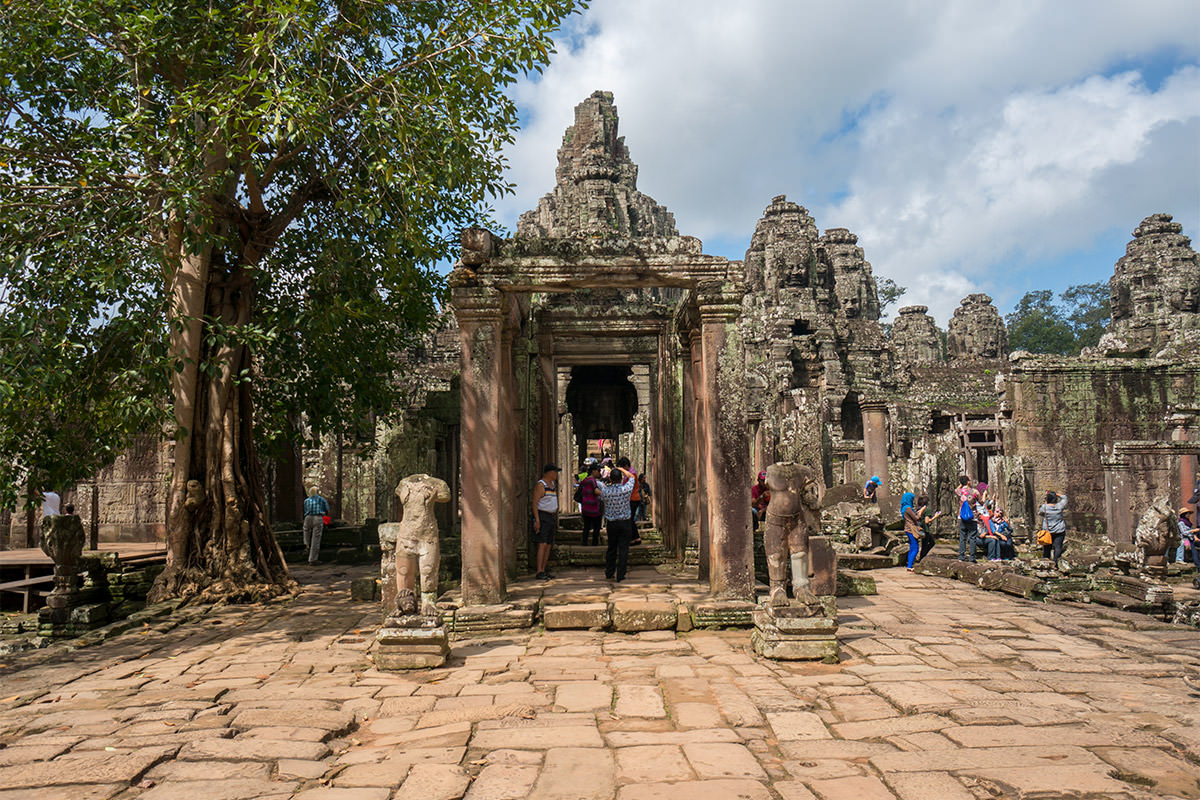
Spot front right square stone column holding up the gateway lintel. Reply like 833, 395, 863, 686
697, 283, 754, 601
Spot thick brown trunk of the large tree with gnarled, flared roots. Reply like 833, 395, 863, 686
150, 251, 295, 602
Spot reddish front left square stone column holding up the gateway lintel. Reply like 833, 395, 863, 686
451, 285, 505, 606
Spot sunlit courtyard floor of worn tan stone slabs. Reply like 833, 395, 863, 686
0, 567, 1200, 800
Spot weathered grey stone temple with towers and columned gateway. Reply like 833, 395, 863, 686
4, 91, 1200, 618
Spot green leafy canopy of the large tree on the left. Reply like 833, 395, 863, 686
0, 0, 581, 500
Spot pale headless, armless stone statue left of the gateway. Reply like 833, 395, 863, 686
379, 474, 451, 616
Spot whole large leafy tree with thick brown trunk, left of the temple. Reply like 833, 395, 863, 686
0, 0, 578, 597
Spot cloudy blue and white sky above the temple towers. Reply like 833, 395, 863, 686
498, 0, 1200, 323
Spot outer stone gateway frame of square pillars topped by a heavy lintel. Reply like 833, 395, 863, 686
449, 228, 754, 606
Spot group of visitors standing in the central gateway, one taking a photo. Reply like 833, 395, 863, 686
532, 457, 650, 583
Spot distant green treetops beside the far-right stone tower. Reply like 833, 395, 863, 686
1004, 282, 1111, 355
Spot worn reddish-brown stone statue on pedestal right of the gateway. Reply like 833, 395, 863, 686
763, 461, 824, 608
